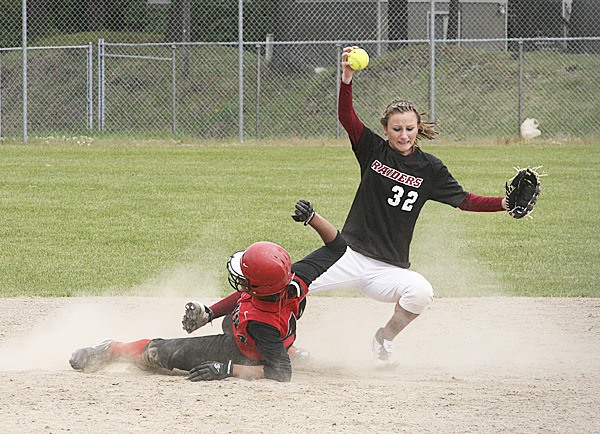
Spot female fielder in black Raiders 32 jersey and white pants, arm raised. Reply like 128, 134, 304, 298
310, 47, 506, 367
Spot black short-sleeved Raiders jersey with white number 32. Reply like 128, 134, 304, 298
342, 126, 468, 268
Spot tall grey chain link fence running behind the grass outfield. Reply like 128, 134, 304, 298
0, 0, 600, 141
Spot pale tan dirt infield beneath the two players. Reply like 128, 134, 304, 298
0, 296, 600, 433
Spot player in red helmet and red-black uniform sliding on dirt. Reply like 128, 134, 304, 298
70, 201, 346, 381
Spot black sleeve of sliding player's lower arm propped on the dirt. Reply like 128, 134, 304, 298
246, 321, 292, 382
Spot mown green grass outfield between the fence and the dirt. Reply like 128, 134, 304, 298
0, 140, 600, 297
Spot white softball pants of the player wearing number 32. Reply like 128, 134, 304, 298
309, 247, 433, 314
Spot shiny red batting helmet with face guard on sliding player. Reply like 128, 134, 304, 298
227, 241, 292, 297
